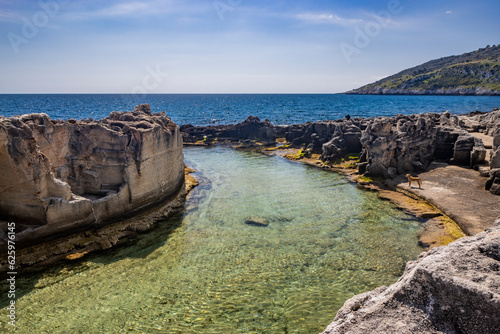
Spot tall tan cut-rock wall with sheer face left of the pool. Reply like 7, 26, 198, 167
0, 105, 184, 244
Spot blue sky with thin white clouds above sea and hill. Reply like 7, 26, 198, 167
0, 0, 500, 94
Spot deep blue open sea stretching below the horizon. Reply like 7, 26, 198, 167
0, 94, 500, 125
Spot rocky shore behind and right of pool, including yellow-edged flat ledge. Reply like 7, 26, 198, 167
181, 108, 500, 249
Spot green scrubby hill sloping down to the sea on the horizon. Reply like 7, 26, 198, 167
346, 45, 500, 95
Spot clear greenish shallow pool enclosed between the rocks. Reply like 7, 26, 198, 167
0, 148, 422, 333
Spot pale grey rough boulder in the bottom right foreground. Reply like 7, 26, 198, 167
323, 220, 500, 334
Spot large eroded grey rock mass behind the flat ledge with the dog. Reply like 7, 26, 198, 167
316, 112, 487, 178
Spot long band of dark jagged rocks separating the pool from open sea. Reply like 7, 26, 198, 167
181, 110, 500, 193
